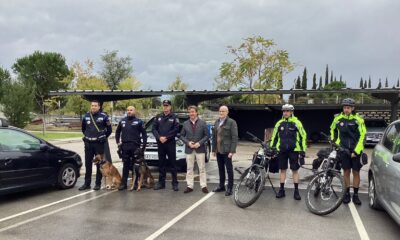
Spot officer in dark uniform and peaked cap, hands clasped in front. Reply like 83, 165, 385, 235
152, 100, 179, 191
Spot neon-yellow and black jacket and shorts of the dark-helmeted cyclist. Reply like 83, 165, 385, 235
331, 112, 367, 172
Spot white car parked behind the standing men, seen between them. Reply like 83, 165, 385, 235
144, 113, 212, 171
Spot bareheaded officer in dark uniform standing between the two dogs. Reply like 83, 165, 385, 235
115, 106, 147, 191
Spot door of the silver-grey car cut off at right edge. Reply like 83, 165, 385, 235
386, 123, 400, 218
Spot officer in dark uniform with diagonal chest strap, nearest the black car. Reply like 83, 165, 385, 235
79, 100, 112, 190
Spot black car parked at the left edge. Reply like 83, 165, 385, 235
0, 119, 82, 195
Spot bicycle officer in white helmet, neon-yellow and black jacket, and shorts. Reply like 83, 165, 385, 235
271, 104, 307, 200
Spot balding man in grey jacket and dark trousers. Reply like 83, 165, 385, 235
212, 105, 238, 196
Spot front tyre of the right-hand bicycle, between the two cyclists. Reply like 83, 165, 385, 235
305, 171, 346, 216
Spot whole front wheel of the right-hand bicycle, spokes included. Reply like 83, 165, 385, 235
305, 171, 346, 215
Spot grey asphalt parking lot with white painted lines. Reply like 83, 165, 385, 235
0, 140, 400, 239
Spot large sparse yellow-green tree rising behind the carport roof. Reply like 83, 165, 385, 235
215, 36, 294, 96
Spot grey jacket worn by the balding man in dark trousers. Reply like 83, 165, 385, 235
212, 117, 238, 154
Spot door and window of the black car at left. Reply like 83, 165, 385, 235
0, 128, 52, 187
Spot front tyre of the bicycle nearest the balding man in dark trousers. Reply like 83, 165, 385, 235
233, 165, 265, 208
